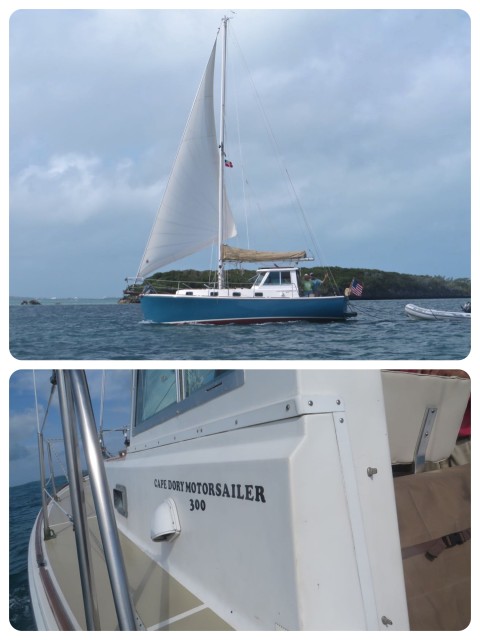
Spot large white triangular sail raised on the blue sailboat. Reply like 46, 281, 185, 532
138, 43, 236, 278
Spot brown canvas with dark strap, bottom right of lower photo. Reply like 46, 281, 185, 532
394, 464, 471, 631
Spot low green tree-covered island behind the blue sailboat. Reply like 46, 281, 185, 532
119, 267, 471, 303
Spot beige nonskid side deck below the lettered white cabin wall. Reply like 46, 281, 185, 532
39, 481, 230, 630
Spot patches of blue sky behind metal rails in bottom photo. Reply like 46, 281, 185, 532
9, 369, 132, 486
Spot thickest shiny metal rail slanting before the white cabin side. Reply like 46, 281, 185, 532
69, 371, 137, 631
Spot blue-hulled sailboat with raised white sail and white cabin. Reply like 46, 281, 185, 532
134, 17, 356, 324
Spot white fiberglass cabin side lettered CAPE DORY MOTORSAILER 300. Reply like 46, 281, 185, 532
106, 371, 408, 630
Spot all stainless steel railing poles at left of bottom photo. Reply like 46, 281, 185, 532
35, 370, 139, 631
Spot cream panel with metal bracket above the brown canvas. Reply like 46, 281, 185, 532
382, 371, 470, 464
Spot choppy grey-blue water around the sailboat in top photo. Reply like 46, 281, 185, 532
10, 299, 471, 360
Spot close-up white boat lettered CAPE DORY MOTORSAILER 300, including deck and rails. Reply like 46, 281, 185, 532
29, 370, 470, 631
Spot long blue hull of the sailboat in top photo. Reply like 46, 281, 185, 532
140, 294, 357, 324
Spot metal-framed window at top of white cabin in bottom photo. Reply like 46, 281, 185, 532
133, 369, 243, 436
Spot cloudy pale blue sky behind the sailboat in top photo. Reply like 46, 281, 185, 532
9, 9, 471, 298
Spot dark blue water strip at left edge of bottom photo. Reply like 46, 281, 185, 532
9, 482, 41, 631
